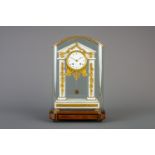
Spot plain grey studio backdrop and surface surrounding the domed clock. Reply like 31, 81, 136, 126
0, 27, 155, 129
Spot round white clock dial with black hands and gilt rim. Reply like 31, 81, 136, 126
67, 51, 87, 70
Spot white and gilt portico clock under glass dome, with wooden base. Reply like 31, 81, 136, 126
49, 36, 105, 121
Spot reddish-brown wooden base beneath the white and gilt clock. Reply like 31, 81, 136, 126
49, 109, 105, 121
